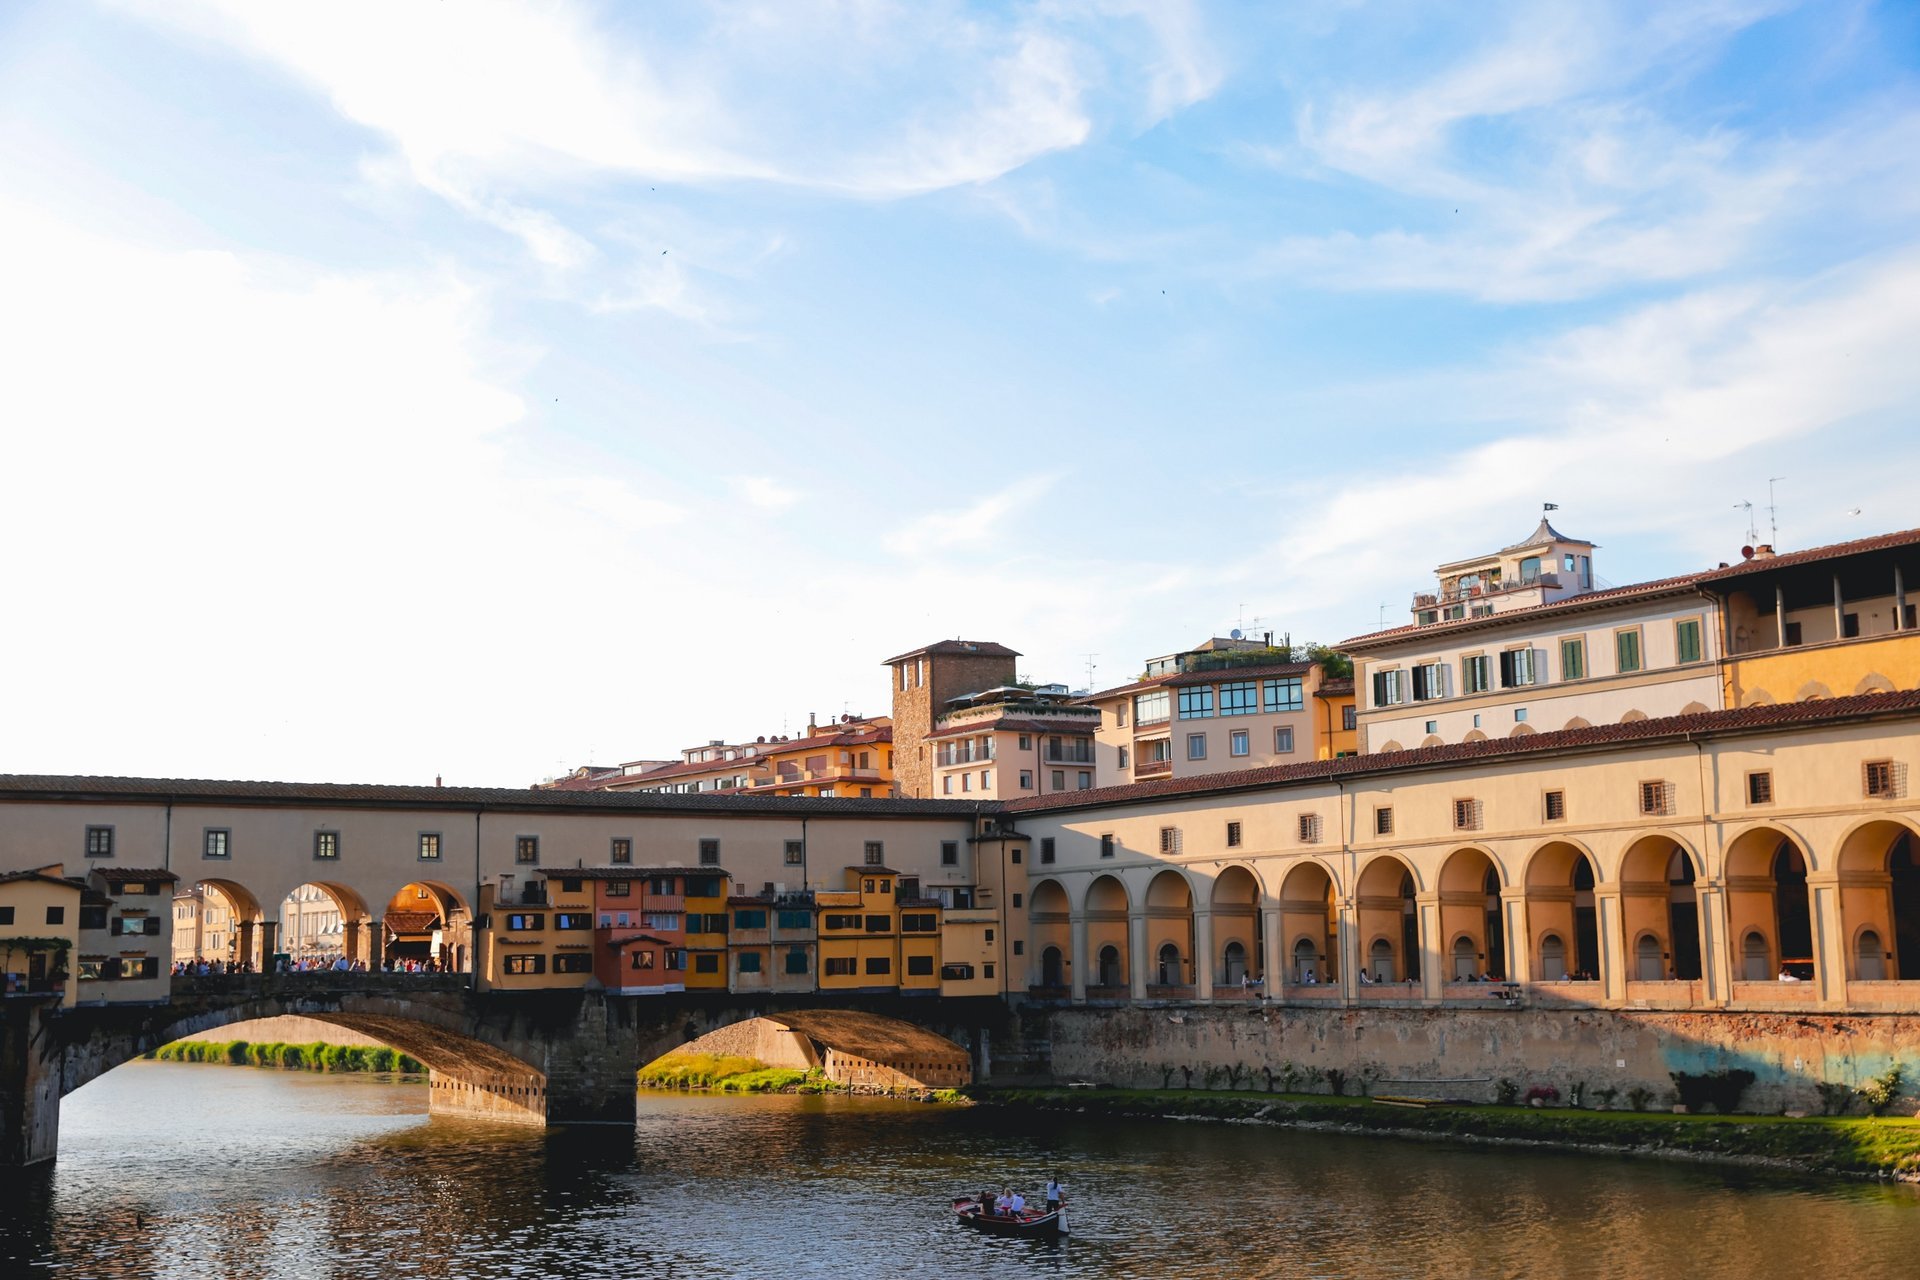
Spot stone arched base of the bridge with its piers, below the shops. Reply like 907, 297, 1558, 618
0, 971, 1012, 1167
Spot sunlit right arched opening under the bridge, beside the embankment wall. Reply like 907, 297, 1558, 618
641, 1009, 973, 1092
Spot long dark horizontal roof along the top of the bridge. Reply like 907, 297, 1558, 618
0, 773, 991, 818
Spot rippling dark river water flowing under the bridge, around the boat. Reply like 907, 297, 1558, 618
11, 1061, 1920, 1280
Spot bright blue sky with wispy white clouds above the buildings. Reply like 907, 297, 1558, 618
0, 0, 1920, 787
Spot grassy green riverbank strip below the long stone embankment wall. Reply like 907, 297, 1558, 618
962, 1086, 1920, 1180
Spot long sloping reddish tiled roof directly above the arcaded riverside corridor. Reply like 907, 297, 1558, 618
1000, 689, 1920, 814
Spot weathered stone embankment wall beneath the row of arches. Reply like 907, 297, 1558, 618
1029, 1006, 1920, 1113
